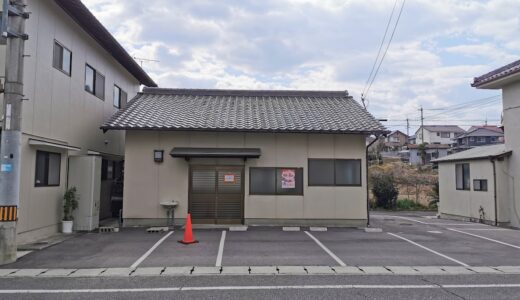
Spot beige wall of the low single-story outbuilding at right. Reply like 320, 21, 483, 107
439, 159, 509, 223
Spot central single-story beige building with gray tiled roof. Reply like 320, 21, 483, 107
102, 88, 388, 226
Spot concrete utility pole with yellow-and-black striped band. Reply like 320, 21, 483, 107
0, 0, 29, 265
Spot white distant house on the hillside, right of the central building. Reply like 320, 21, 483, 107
415, 125, 466, 145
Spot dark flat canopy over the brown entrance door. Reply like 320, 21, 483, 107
170, 147, 260, 159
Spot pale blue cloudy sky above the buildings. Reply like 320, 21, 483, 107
83, 0, 520, 132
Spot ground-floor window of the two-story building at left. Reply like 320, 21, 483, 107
34, 151, 61, 187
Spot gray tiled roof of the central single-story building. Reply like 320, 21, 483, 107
101, 88, 388, 134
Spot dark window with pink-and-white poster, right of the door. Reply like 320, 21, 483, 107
249, 168, 303, 195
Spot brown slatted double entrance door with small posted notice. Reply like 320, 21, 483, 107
189, 166, 244, 224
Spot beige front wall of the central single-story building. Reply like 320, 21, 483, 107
123, 131, 367, 224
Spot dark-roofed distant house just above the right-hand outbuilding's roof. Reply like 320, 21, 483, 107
454, 126, 504, 152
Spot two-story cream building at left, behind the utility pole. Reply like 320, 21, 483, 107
0, 0, 156, 243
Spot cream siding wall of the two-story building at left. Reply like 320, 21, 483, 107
0, 0, 140, 243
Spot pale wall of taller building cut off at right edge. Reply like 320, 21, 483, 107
502, 80, 520, 227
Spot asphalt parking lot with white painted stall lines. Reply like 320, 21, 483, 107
2, 213, 520, 269
